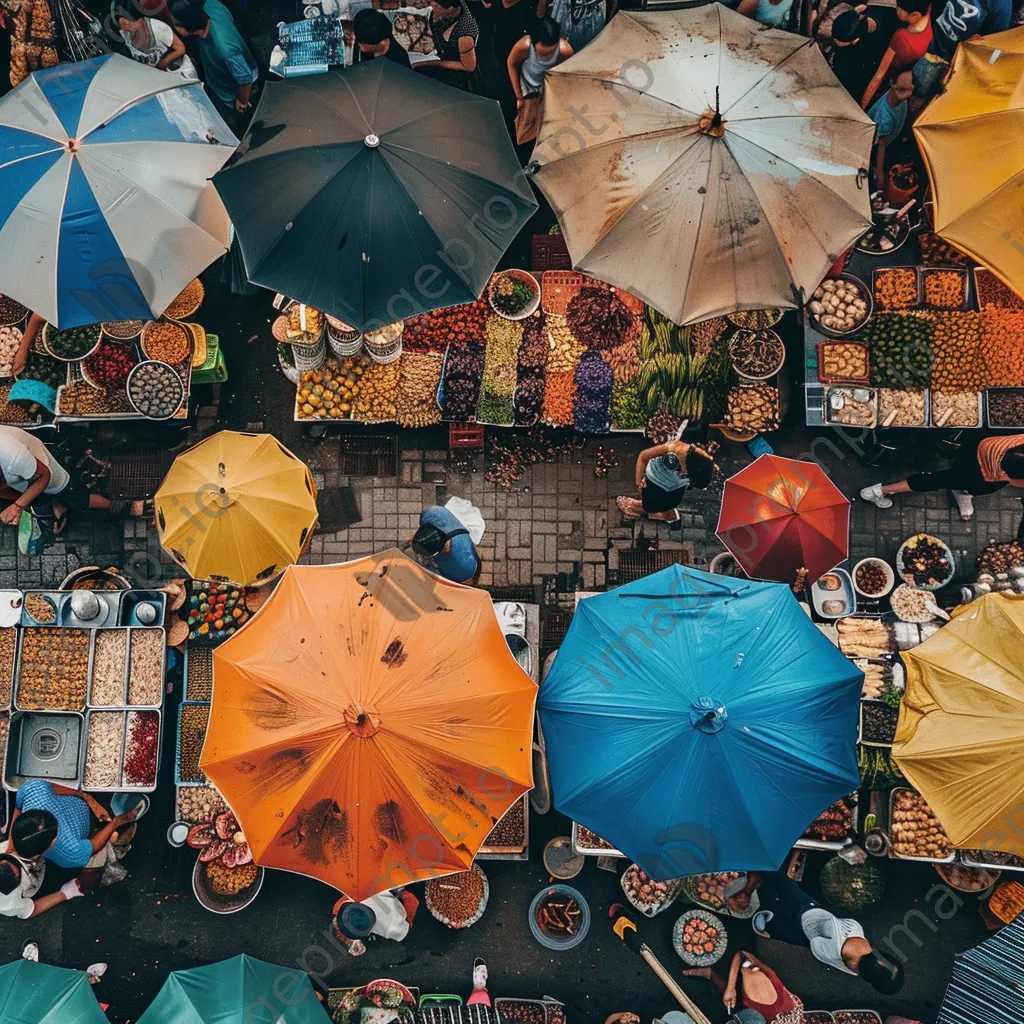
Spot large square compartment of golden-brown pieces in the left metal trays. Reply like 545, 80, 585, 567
17, 627, 89, 711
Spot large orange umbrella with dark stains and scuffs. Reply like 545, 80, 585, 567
201, 550, 537, 900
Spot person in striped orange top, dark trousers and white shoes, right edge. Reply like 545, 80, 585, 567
860, 434, 1024, 520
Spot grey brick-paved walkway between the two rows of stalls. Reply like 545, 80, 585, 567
9, 421, 1021, 602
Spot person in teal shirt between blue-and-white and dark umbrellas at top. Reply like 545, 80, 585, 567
171, 0, 259, 129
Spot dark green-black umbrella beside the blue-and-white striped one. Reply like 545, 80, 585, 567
214, 60, 537, 327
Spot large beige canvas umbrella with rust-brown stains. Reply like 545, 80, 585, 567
534, 4, 874, 324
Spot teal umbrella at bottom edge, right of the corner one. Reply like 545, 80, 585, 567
138, 953, 331, 1024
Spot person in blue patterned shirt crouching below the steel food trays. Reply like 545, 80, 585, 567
11, 778, 138, 885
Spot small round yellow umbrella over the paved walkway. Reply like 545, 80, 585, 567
154, 430, 316, 586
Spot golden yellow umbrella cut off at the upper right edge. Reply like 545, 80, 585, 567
913, 28, 1024, 295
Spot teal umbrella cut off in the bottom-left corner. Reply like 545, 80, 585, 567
0, 959, 109, 1024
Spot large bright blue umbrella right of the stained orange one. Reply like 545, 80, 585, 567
539, 565, 863, 880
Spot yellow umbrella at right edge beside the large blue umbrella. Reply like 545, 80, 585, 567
893, 593, 1024, 853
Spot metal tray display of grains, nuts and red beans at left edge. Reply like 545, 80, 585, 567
0, 590, 167, 793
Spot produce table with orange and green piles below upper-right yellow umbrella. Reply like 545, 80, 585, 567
804, 228, 1024, 429
